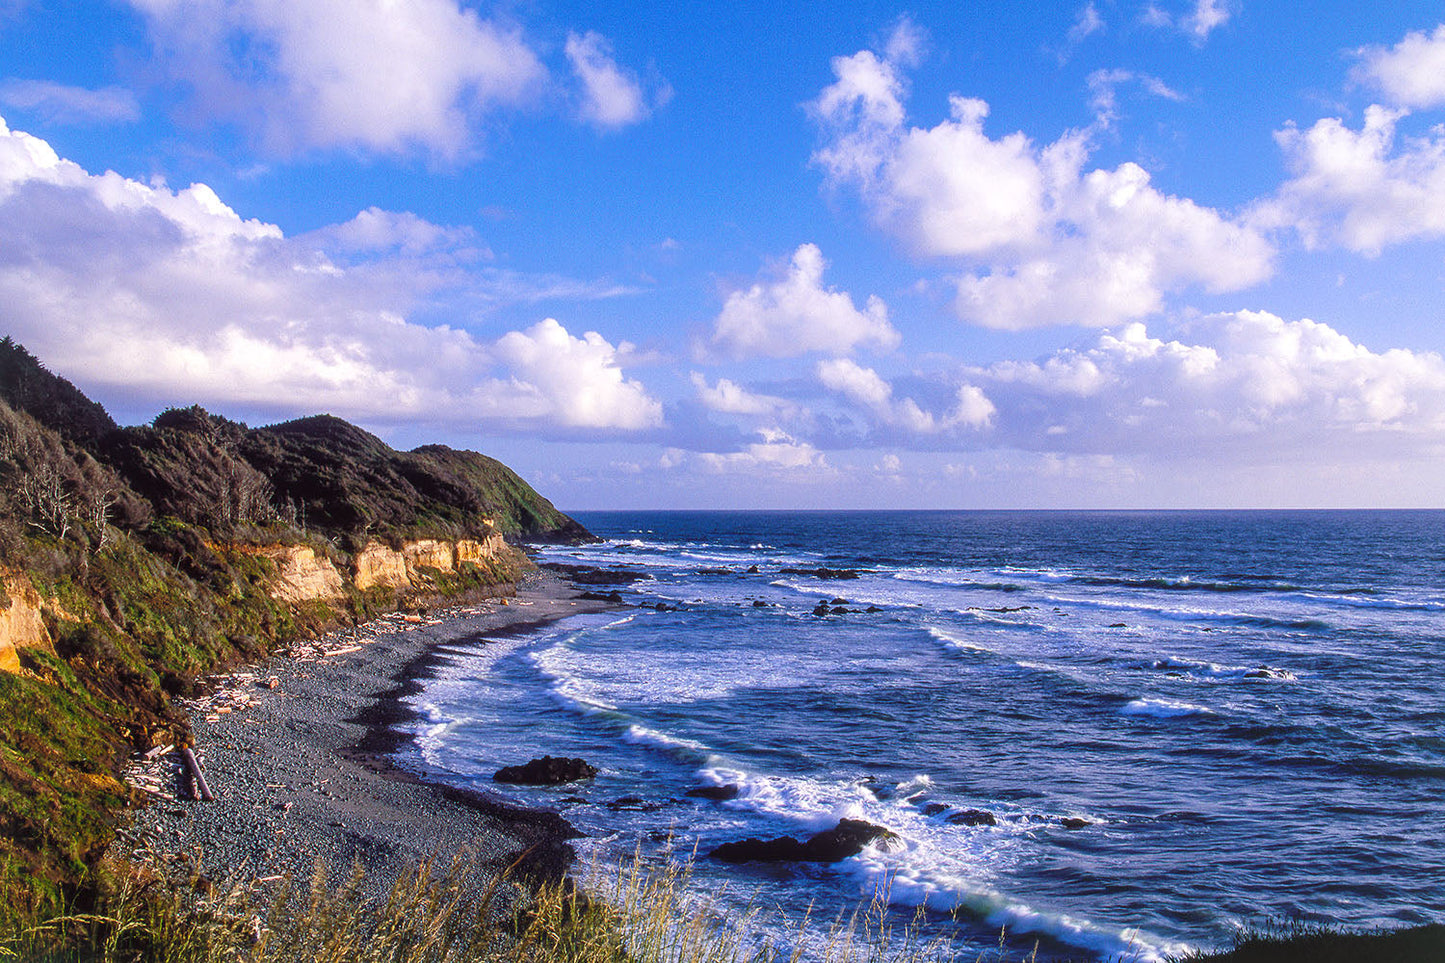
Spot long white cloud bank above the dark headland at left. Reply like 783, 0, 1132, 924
0, 108, 662, 431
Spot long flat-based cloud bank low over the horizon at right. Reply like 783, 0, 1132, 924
964, 311, 1445, 458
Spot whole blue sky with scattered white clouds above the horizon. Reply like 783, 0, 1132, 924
0, 0, 1445, 510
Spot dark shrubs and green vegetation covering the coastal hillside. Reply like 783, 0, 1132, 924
0, 338, 587, 910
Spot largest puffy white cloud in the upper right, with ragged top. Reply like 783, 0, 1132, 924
812, 51, 1274, 330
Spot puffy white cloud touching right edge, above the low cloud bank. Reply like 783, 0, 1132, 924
1253, 106, 1445, 254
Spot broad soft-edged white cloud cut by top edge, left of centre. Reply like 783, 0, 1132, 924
130, 0, 546, 158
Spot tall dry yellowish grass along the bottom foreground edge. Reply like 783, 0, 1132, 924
0, 859, 1032, 963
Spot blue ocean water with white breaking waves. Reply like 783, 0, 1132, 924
401, 512, 1445, 960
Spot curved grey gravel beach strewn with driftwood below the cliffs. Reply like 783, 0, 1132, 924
118, 571, 608, 892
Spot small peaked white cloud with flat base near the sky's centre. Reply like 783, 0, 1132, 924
711, 244, 899, 357
